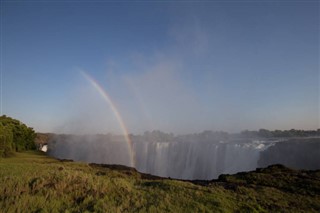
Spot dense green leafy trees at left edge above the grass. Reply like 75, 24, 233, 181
0, 115, 36, 157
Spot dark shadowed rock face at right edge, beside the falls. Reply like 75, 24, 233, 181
258, 138, 320, 169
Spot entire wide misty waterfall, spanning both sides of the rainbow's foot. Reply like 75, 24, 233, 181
48, 135, 280, 180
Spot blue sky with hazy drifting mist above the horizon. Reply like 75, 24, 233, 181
1, 0, 320, 133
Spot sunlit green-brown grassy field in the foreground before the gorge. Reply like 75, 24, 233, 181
0, 152, 320, 212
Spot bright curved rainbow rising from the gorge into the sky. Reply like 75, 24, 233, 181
80, 71, 135, 167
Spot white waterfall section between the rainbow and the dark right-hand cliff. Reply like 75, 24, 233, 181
134, 142, 265, 179
